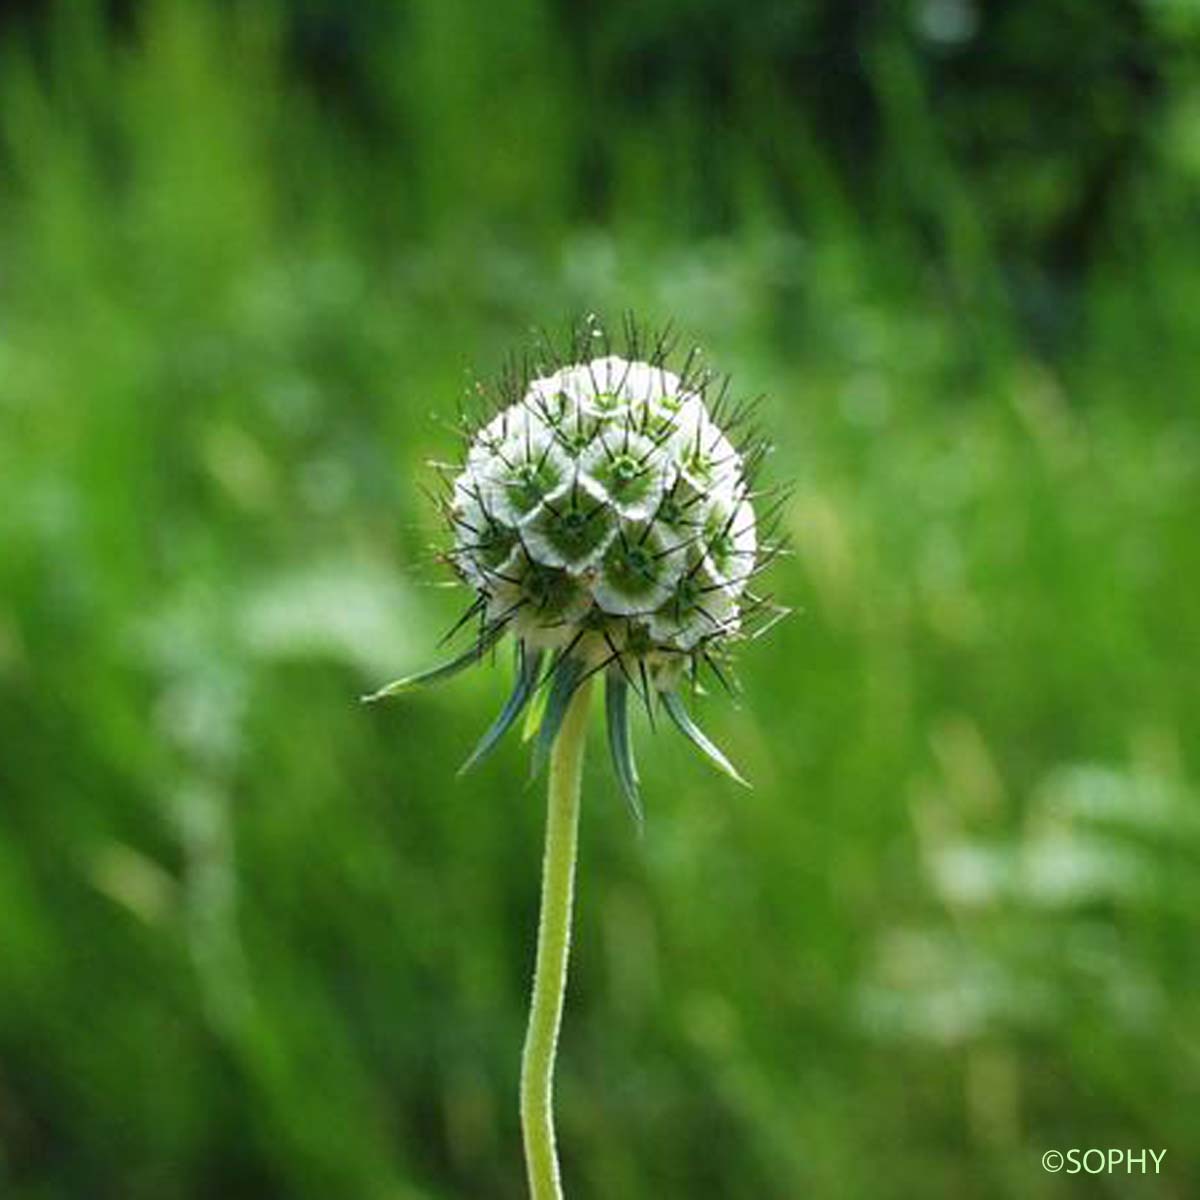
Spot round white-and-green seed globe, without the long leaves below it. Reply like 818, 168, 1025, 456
450, 333, 777, 671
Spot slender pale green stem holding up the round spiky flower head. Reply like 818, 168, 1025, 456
521, 679, 592, 1200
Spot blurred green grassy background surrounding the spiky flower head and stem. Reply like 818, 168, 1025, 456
0, 0, 1200, 1200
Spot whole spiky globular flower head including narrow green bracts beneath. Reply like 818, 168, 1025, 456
364, 320, 779, 808
